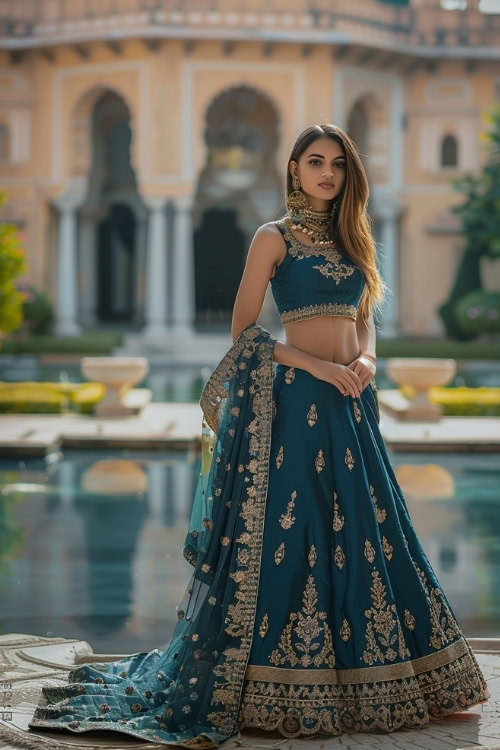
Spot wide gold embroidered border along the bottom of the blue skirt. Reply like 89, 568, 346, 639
238, 637, 489, 738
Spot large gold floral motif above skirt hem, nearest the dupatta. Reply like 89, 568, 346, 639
269, 575, 335, 667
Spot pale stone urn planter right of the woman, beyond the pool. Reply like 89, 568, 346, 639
387, 357, 457, 422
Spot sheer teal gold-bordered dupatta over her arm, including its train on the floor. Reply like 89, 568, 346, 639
25, 323, 276, 748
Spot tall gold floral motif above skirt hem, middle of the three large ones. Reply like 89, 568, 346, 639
360, 568, 411, 666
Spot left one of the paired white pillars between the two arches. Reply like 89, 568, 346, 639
143, 196, 168, 338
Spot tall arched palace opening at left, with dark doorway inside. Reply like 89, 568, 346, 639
70, 85, 147, 328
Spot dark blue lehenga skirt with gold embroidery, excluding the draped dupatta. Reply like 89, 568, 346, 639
239, 364, 488, 737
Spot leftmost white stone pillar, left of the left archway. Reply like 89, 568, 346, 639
54, 190, 82, 336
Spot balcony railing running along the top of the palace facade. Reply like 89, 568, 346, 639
0, 0, 500, 54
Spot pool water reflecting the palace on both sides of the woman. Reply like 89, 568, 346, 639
0, 451, 500, 654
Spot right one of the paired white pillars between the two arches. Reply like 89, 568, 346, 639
172, 195, 196, 337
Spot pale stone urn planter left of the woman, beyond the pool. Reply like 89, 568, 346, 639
80, 357, 149, 417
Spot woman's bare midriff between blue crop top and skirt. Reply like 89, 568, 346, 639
285, 315, 361, 365
